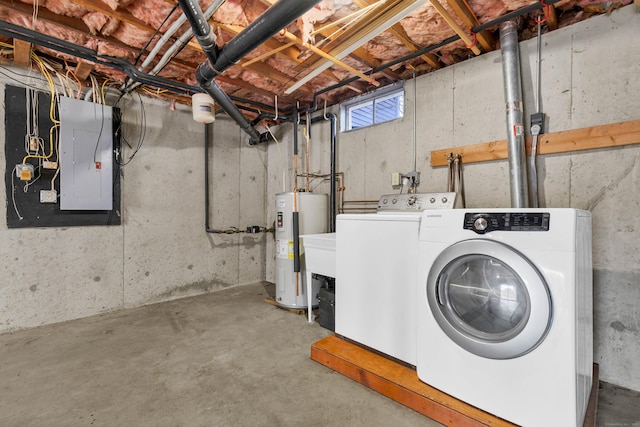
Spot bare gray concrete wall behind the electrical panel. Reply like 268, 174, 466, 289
0, 77, 266, 332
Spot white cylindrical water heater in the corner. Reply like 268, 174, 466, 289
276, 193, 329, 308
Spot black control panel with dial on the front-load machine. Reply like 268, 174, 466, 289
463, 212, 550, 234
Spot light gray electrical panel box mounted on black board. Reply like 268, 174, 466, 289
59, 97, 113, 210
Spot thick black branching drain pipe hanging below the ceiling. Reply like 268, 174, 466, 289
179, 0, 320, 145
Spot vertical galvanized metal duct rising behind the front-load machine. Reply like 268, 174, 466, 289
500, 21, 529, 208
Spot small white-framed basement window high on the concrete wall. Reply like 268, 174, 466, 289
340, 84, 404, 131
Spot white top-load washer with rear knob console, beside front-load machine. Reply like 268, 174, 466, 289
335, 193, 455, 366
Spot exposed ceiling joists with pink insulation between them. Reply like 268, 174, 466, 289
0, 0, 632, 117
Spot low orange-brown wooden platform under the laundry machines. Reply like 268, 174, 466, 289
311, 335, 598, 427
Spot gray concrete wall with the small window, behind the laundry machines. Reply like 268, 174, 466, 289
267, 6, 640, 390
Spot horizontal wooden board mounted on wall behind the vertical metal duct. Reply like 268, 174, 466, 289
431, 120, 640, 167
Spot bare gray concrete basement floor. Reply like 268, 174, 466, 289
0, 283, 640, 427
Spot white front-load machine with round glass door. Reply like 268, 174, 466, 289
416, 208, 597, 427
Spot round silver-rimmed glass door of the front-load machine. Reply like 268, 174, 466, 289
427, 239, 553, 359
